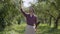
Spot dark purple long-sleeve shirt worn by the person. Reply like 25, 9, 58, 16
21, 9, 37, 26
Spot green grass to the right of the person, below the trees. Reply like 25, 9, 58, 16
37, 24, 60, 34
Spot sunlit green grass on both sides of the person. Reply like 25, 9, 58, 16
0, 23, 60, 34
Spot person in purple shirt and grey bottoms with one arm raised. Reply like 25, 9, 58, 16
21, 7, 37, 34
